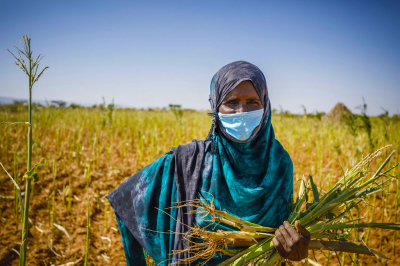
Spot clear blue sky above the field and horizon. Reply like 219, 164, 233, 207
0, 0, 400, 115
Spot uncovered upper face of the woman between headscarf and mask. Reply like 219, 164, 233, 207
218, 80, 263, 114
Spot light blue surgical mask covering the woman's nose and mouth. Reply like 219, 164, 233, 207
218, 109, 264, 140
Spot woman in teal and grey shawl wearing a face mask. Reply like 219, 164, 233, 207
107, 61, 310, 265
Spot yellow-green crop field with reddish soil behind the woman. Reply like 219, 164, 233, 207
0, 104, 400, 265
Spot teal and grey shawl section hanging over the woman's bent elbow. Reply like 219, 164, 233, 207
107, 154, 177, 266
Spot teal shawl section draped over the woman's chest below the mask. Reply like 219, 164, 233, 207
197, 107, 293, 230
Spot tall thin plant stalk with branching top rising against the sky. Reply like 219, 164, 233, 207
7, 35, 49, 266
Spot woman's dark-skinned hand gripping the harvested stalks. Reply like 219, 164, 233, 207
272, 221, 311, 261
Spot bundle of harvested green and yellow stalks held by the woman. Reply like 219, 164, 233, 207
169, 147, 400, 266
